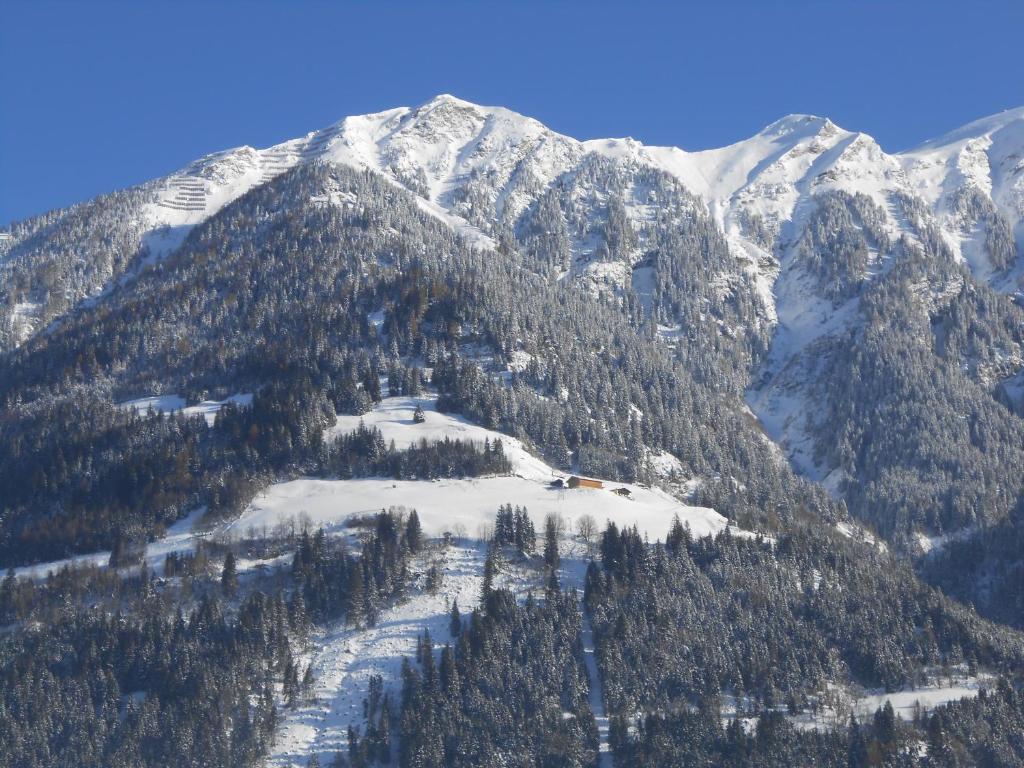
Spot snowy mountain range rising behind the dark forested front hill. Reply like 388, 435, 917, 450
0, 95, 1024, 577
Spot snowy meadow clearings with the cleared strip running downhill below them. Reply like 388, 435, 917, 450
9, 395, 737, 766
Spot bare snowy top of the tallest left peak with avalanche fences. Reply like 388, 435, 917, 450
138, 95, 583, 256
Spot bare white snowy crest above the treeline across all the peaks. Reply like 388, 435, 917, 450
136, 94, 1024, 266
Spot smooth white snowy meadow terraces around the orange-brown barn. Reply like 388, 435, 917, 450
17, 394, 737, 578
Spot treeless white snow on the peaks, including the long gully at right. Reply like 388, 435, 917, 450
114, 95, 1024, 486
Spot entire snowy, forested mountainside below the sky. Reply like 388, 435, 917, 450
6, 96, 1024, 768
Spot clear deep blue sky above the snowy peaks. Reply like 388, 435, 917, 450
0, 0, 1024, 222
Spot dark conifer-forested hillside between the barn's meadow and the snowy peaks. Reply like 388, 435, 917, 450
0, 166, 843, 562
